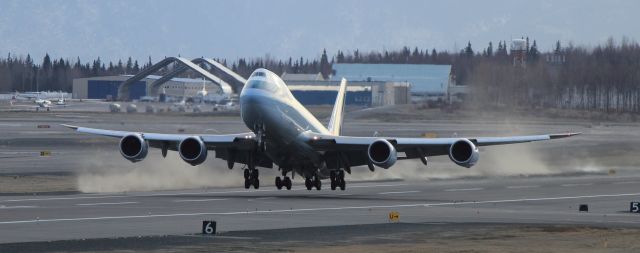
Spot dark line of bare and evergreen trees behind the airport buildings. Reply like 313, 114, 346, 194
0, 38, 640, 112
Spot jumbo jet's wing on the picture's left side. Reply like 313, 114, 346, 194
62, 124, 273, 168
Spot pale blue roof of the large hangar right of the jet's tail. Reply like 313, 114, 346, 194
331, 63, 451, 94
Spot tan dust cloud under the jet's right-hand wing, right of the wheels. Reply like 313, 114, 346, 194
350, 122, 596, 180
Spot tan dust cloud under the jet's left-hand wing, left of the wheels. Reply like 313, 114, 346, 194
77, 150, 244, 193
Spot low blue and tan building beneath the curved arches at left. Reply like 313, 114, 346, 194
73, 75, 221, 100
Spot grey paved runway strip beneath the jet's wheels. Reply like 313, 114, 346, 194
0, 173, 640, 243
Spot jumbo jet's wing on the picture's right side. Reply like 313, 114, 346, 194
304, 132, 580, 166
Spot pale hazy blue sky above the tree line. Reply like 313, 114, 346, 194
0, 0, 640, 62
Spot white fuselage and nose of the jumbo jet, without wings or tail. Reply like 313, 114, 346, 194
239, 69, 329, 175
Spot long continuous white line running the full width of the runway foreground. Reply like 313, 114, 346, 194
0, 193, 640, 225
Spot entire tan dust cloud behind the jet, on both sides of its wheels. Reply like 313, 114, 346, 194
77, 119, 596, 193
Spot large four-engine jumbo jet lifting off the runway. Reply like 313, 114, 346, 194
65, 69, 579, 190
